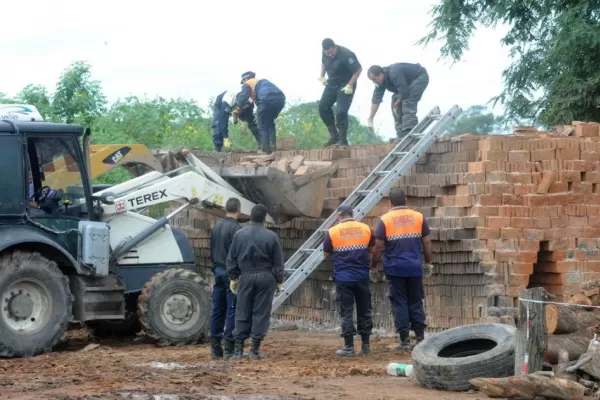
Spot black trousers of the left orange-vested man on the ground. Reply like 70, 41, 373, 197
335, 279, 373, 337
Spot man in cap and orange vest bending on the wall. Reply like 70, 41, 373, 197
237, 71, 285, 154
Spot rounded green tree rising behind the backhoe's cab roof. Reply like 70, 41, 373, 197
52, 61, 106, 126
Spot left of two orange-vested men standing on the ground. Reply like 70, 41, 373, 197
323, 205, 375, 357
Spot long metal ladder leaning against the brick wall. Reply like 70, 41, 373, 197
272, 105, 462, 312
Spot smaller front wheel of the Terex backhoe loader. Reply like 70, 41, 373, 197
138, 269, 212, 346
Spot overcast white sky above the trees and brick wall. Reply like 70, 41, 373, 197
0, 0, 509, 137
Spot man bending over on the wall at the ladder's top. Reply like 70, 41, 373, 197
367, 63, 429, 141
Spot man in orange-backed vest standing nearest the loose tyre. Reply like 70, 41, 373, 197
371, 188, 433, 350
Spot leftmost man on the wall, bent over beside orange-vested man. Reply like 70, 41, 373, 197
211, 88, 260, 151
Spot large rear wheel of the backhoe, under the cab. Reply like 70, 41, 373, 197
0, 251, 73, 357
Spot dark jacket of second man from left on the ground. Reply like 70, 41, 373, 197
227, 222, 283, 283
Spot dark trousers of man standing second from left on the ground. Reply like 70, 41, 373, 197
233, 272, 276, 340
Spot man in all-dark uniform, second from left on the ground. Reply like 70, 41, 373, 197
227, 204, 283, 360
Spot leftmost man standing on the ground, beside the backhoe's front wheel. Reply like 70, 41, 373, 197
210, 197, 242, 360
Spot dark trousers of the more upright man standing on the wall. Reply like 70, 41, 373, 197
319, 84, 357, 135
